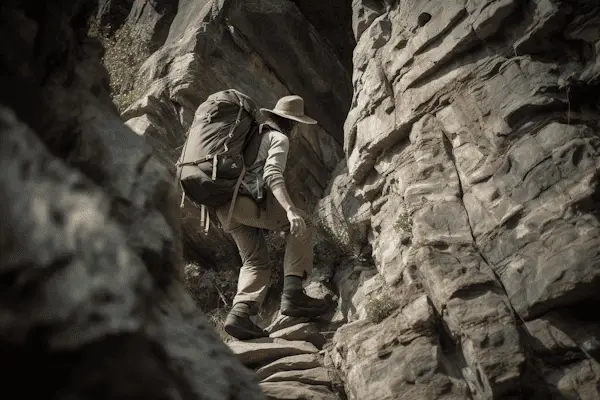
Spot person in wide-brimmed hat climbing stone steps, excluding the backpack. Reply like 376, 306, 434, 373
179, 92, 329, 340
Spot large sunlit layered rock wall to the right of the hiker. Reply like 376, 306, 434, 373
319, 0, 600, 400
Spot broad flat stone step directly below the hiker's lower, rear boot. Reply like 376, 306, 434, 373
227, 338, 319, 366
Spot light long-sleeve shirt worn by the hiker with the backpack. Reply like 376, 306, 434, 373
243, 125, 290, 200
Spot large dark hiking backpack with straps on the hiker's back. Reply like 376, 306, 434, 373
176, 89, 260, 232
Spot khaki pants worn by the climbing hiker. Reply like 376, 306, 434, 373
217, 192, 314, 307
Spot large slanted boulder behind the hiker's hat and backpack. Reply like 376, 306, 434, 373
123, 0, 352, 266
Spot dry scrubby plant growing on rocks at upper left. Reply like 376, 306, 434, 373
89, 20, 151, 112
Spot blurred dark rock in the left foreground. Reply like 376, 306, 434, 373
0, 1, 264, 400
